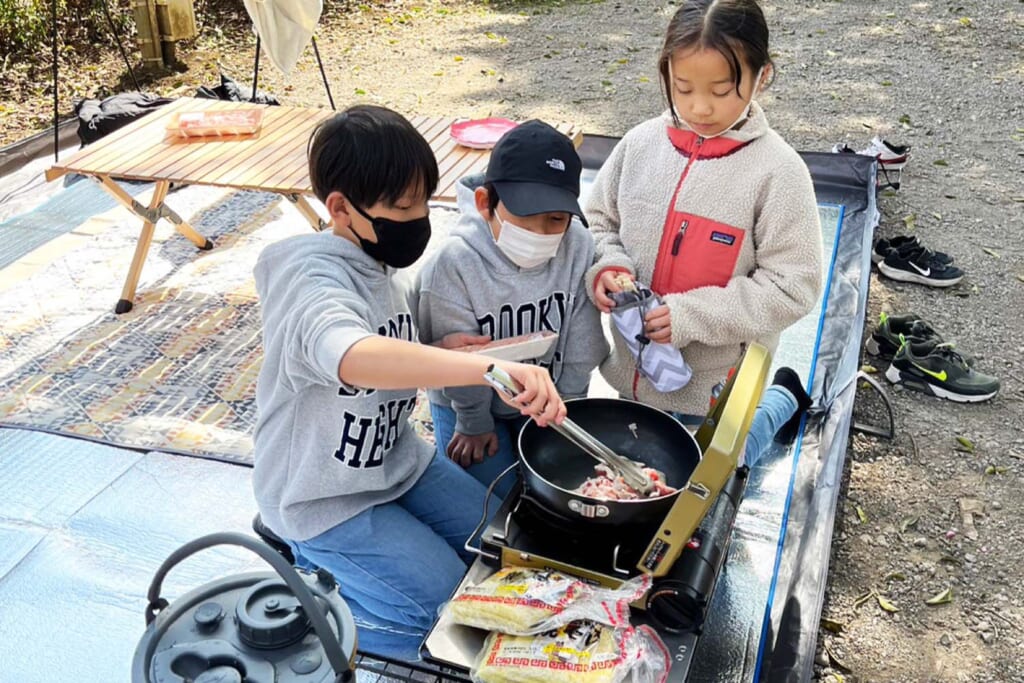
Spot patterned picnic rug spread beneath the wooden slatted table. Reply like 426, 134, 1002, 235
0, 187, 299, 463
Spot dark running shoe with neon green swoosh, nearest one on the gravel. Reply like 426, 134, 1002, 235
886, 339, 999, 403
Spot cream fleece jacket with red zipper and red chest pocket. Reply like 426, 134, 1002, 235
584, 102, 823, 415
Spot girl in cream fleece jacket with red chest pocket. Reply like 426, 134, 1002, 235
585, 0, 822, 415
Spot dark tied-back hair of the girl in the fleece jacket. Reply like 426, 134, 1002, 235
657, 0, 774, 123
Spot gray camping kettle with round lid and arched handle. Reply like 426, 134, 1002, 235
131, 532, 356, 683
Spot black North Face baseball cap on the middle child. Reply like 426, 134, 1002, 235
484, 119, 589, 227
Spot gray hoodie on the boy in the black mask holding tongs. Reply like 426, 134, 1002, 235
253, 231, 432, 541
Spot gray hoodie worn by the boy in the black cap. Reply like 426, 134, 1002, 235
415, 176, 608, 435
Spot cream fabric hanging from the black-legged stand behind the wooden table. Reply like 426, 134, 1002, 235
244, 0, 324, 76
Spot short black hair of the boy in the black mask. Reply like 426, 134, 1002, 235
307, 104, 438, 209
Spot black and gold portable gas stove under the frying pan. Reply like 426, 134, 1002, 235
423, 344, 770, 681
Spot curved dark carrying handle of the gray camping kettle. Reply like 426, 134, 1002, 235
145, 531, 352, 683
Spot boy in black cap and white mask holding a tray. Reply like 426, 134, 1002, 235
416, 121, 608, 497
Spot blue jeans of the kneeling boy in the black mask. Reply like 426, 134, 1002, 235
287, 457, 499, 661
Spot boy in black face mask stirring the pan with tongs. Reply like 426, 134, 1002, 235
253, 106, 565, 659
